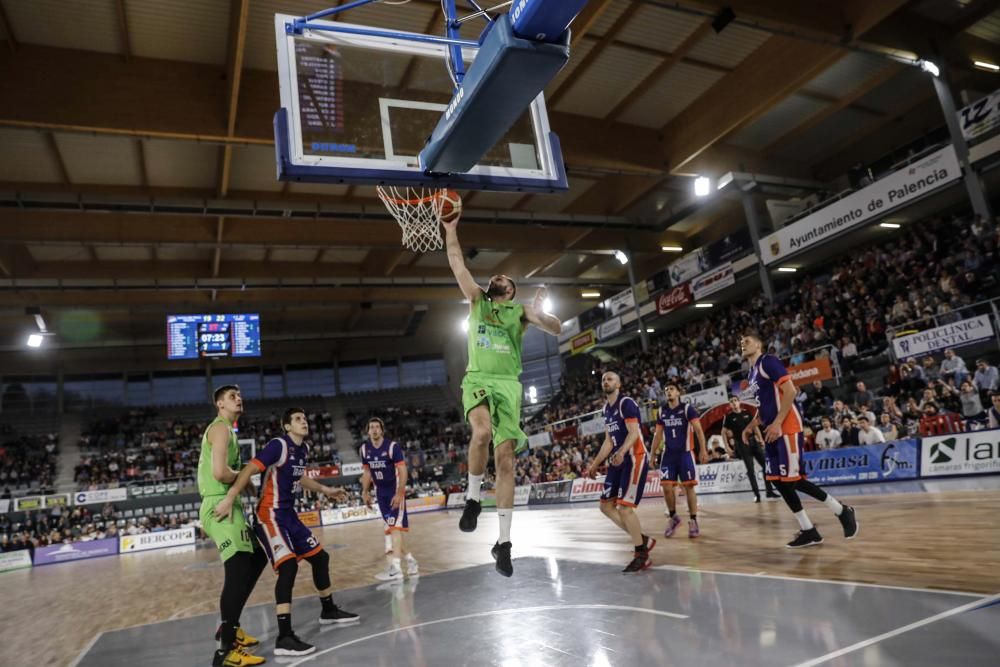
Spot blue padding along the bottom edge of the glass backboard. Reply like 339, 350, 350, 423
274, 109, 569, 193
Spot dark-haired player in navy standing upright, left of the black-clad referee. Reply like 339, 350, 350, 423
653, 382, 708, 537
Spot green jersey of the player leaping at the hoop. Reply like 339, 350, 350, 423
465, 294, 524, 380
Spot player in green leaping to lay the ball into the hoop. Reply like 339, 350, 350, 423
441, 211, 562, 577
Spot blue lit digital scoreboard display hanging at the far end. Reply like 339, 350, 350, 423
167, 313, 260, 359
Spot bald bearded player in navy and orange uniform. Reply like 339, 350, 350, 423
585, 372, 656, 572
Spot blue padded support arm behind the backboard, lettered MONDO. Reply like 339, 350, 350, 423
420, 14, 569, 173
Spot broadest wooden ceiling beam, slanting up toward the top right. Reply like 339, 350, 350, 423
662, 0, 906, 172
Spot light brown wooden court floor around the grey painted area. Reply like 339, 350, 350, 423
0, 489, 1000, 665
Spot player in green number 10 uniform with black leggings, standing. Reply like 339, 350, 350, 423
198, 384, 267, 667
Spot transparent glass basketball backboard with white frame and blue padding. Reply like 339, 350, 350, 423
274, 14, 567, 192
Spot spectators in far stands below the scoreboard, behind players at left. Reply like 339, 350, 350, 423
74, 408, 340, 490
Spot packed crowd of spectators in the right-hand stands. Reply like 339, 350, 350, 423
537, 211, 1000, 452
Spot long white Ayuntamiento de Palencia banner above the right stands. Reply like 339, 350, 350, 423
760, 144, 962, 264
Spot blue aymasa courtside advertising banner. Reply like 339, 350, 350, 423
802, 440, 918, 485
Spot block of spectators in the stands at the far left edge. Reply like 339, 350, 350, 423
0, 424, 59, 498
